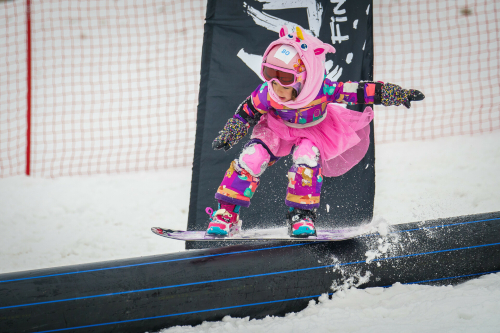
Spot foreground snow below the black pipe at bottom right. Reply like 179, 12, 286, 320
160, 274, 500, 333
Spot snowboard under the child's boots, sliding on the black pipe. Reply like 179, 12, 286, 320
151, 223, 373, 242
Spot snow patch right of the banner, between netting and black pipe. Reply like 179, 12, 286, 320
374, 131, 500, 224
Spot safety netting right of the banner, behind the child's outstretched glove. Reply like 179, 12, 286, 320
373, 0, 500, 143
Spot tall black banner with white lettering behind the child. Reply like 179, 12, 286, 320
186, 0, 375, 248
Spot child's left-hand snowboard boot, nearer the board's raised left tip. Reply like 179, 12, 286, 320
206, 203, 241, 237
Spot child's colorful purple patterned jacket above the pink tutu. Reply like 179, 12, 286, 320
234, 78, 382, 125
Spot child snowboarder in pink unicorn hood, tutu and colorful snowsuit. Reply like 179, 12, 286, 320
207, 26, 424, 237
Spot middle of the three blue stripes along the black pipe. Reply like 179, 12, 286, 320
0, 243, 500, 310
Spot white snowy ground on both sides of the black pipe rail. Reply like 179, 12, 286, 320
0, 131, 500, 333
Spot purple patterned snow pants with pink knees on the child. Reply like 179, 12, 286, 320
215, 139, 323, 209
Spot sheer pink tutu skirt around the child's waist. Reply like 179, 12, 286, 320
251, 104, 373, 177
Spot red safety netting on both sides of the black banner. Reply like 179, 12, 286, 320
0, 0, 500, 177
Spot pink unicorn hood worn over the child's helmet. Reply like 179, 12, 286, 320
263, 26, 335, 109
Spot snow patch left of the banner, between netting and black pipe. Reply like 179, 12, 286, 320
0, 169, 191, 273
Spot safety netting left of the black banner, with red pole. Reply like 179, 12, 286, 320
0, 0, 206, 177
